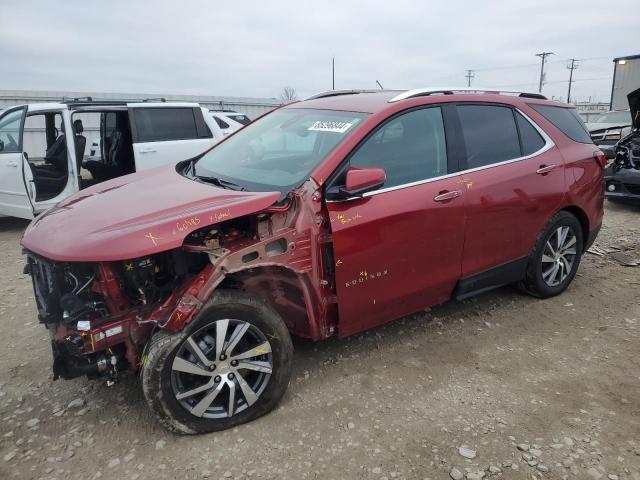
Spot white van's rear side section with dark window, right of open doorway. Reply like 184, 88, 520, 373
129, 105, 213, 171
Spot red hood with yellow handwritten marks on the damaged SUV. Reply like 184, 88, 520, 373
22, 166, 280, 262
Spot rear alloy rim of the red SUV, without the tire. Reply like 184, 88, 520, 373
542, 226, 577, 287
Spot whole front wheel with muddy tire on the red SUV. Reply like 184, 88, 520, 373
142, 291, 293, 434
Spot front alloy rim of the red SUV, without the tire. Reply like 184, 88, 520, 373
171, 319, 273, 418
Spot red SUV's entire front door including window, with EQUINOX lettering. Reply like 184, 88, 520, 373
326, 107, 465, 335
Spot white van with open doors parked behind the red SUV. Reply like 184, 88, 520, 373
0, 98, 223, 219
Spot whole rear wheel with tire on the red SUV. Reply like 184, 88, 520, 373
519, 211, 584, 298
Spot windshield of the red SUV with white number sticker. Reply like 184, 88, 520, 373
191, 108, 367, 194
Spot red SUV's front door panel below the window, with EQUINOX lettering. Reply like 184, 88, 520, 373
327, 177, 464, 335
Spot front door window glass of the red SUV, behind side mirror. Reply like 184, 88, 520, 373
349, 107, 447, 188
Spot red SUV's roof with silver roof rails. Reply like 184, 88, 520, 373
286, 87, 569, 113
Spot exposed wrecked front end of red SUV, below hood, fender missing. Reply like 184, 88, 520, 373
25, 181, 337, 383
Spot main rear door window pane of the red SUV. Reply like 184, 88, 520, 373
458, 105, 521, 169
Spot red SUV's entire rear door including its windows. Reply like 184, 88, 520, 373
457, 103, 565, 288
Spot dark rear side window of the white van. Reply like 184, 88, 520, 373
134, 108, 199, 142
